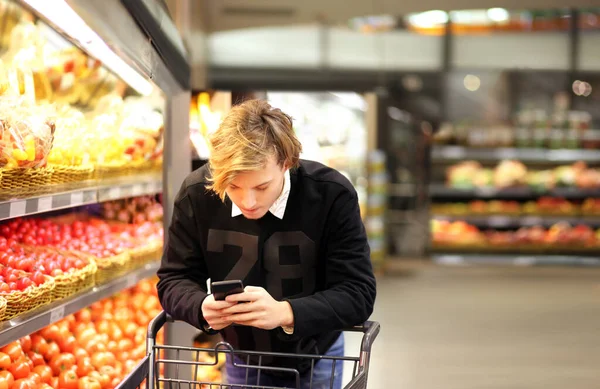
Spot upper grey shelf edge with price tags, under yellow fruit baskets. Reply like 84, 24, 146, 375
0, 175, 162, 220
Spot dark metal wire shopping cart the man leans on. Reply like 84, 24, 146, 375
117, 312, 380, 389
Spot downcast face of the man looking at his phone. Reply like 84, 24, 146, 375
225, 156, 287, 219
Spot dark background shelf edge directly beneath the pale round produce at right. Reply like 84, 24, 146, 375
429, 184, 600, 199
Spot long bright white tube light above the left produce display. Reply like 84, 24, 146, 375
24, 0, 153, 96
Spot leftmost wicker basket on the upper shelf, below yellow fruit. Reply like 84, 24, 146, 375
0, 167, 54, 197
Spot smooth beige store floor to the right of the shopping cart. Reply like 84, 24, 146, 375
346, 265, 600, 389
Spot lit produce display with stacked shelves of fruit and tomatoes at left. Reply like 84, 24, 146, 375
0, 0, 190, 388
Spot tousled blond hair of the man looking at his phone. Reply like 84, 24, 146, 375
208, 100, 302, 201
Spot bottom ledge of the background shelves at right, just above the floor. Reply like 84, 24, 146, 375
431, 253, 600, 267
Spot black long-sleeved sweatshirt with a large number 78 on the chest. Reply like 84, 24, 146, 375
158, 160, 376, 372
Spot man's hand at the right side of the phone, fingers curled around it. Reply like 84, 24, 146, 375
221, 286, 294, 330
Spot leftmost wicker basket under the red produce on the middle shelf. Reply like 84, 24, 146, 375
0, 276, 55, 320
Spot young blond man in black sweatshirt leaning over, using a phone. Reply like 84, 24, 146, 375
158, 100, 376, 388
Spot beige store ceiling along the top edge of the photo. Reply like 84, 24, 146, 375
172, 0, 599, 32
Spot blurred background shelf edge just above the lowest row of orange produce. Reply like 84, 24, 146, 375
431, 215, 600, 228
